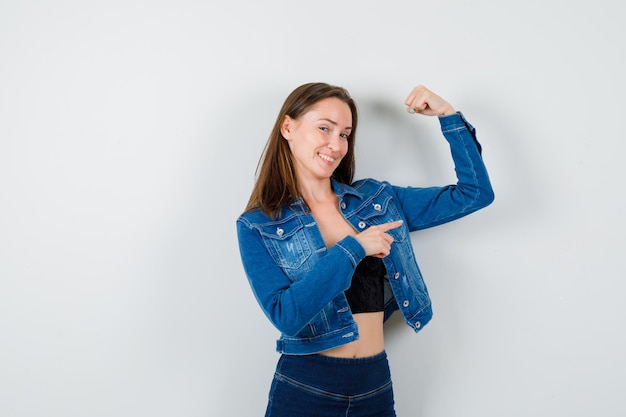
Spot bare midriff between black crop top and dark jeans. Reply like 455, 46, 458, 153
320, 311, 385, 358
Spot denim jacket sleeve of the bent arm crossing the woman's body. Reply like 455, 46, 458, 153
237, 217, 365, 336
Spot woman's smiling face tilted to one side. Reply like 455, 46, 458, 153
281, 97, 352, 184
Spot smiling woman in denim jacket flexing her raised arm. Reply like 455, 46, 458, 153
237, 83, 493, 417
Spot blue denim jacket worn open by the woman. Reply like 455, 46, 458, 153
237, 113, 494, 354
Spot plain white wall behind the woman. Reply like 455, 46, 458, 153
0, 0, 626, 417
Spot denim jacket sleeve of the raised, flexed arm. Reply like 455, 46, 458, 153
392, 113, 494, 231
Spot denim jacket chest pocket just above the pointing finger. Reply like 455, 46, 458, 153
356, 194, 408, 242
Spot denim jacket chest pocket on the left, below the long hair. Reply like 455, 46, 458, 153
260, 217, 312, 276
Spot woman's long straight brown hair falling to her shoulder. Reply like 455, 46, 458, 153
245, 83, 357, 218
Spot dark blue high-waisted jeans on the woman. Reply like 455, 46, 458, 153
265, 352, 396, 417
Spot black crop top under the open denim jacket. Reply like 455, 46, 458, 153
344, 256, 387, 314
